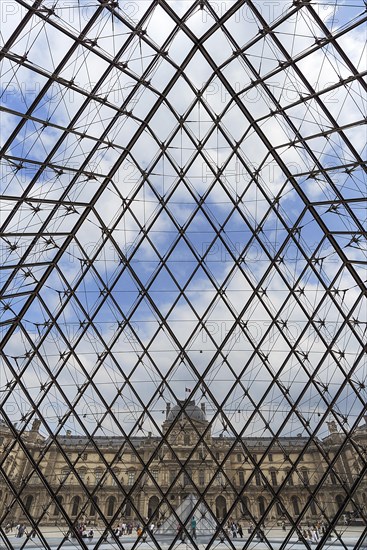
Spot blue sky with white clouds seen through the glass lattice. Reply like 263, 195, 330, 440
1, 2, 366, 440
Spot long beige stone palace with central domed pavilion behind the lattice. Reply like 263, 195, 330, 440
0, 400, 367, 526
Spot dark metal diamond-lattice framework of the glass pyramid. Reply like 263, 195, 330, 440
0, 0, 367, 548
